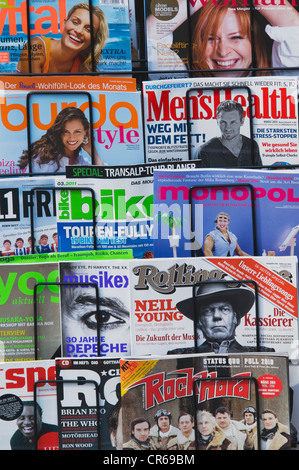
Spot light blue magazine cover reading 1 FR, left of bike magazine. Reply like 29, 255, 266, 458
0, 177, 57, 257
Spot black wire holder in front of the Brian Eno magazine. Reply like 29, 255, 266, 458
33, 379, 101, 450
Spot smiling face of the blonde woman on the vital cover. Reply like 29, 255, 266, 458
62, 8, 100, 52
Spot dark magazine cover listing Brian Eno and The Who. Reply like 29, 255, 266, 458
56, 358, 121, 450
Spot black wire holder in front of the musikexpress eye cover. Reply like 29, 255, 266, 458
33, 281, 101, 360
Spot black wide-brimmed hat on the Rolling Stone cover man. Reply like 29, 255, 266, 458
176, 279, 255, 319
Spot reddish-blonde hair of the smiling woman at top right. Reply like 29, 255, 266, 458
191, 0, 271, 76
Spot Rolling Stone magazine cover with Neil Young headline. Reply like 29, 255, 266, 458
129, 256, 299, 357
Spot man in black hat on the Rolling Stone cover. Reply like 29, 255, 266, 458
169, 280, 274, 354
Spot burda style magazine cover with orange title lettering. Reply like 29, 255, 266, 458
0, 77, 144, 175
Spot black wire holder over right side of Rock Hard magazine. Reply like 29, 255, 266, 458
193, 376, 261, 450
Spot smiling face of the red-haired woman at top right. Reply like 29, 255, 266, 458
205, 11, 252, 77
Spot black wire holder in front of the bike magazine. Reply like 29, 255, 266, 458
30, 186, 97, 253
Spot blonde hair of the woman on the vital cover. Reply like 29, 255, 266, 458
66, 2, 109, 72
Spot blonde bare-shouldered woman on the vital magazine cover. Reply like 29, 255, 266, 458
17, 2, 109, 73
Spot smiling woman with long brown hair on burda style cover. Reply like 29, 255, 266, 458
19, 106, 103, 173
